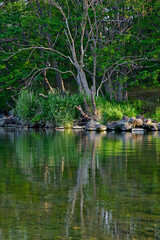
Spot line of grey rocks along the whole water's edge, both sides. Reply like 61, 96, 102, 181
0, 115, 160, 132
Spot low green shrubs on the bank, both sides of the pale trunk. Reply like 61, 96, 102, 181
15, 90, 144, 127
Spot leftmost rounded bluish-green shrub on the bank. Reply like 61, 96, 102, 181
15, 90, 40, 119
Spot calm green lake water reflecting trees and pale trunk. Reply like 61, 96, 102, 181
0, 129, 160, 240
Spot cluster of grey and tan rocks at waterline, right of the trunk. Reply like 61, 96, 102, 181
85, 115, 160, 131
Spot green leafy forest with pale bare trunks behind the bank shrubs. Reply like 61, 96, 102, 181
0, 0, 160, 124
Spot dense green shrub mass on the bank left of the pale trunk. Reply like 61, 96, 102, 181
15, 90, 84, 127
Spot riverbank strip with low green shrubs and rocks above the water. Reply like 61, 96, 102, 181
0, 89, 160, 131
